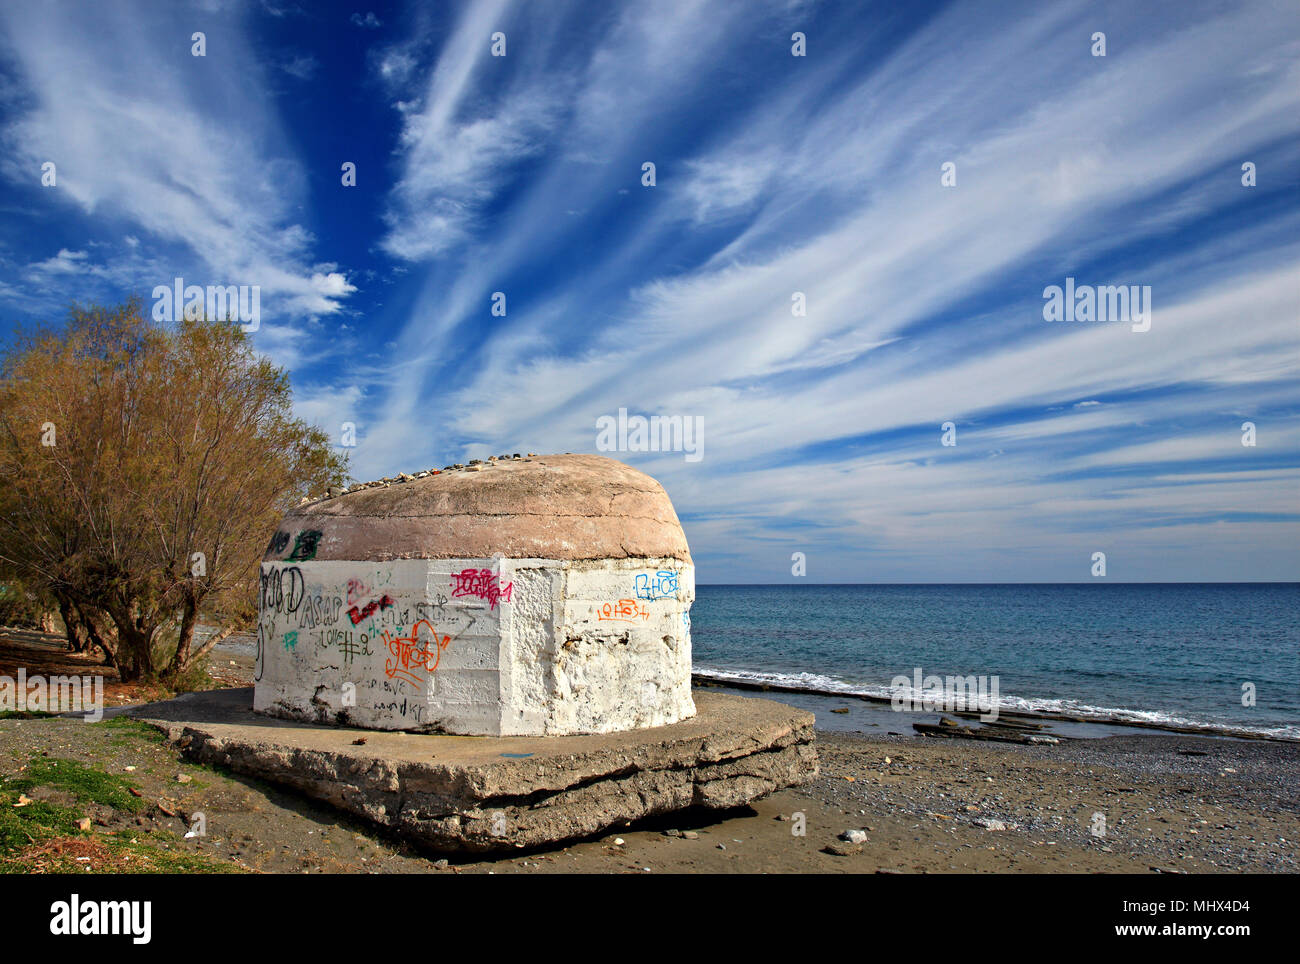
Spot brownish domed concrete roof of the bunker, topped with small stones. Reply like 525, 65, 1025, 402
264, 455, 690, 563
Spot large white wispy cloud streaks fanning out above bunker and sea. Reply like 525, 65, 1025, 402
359, 4, 1300, 578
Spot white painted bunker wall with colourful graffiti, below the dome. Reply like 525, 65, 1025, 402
254, 557, 696, 735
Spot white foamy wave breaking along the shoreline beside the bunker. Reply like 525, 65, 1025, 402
692, 666, 1300, 742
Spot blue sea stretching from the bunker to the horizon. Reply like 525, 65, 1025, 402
690, 583, 1300, 739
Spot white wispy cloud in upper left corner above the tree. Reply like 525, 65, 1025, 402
0, 4, 348, 324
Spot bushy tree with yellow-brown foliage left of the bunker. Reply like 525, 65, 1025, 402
0, 299, 347, 683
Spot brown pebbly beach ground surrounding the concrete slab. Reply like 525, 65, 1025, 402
0, 637, 1300, 873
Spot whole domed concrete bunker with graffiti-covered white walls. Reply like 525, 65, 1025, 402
254, 455, 696, 737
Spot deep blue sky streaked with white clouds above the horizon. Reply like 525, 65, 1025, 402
0, 0, 1300, 582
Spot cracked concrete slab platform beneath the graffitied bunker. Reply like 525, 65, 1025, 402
131, 687, 816, 851
